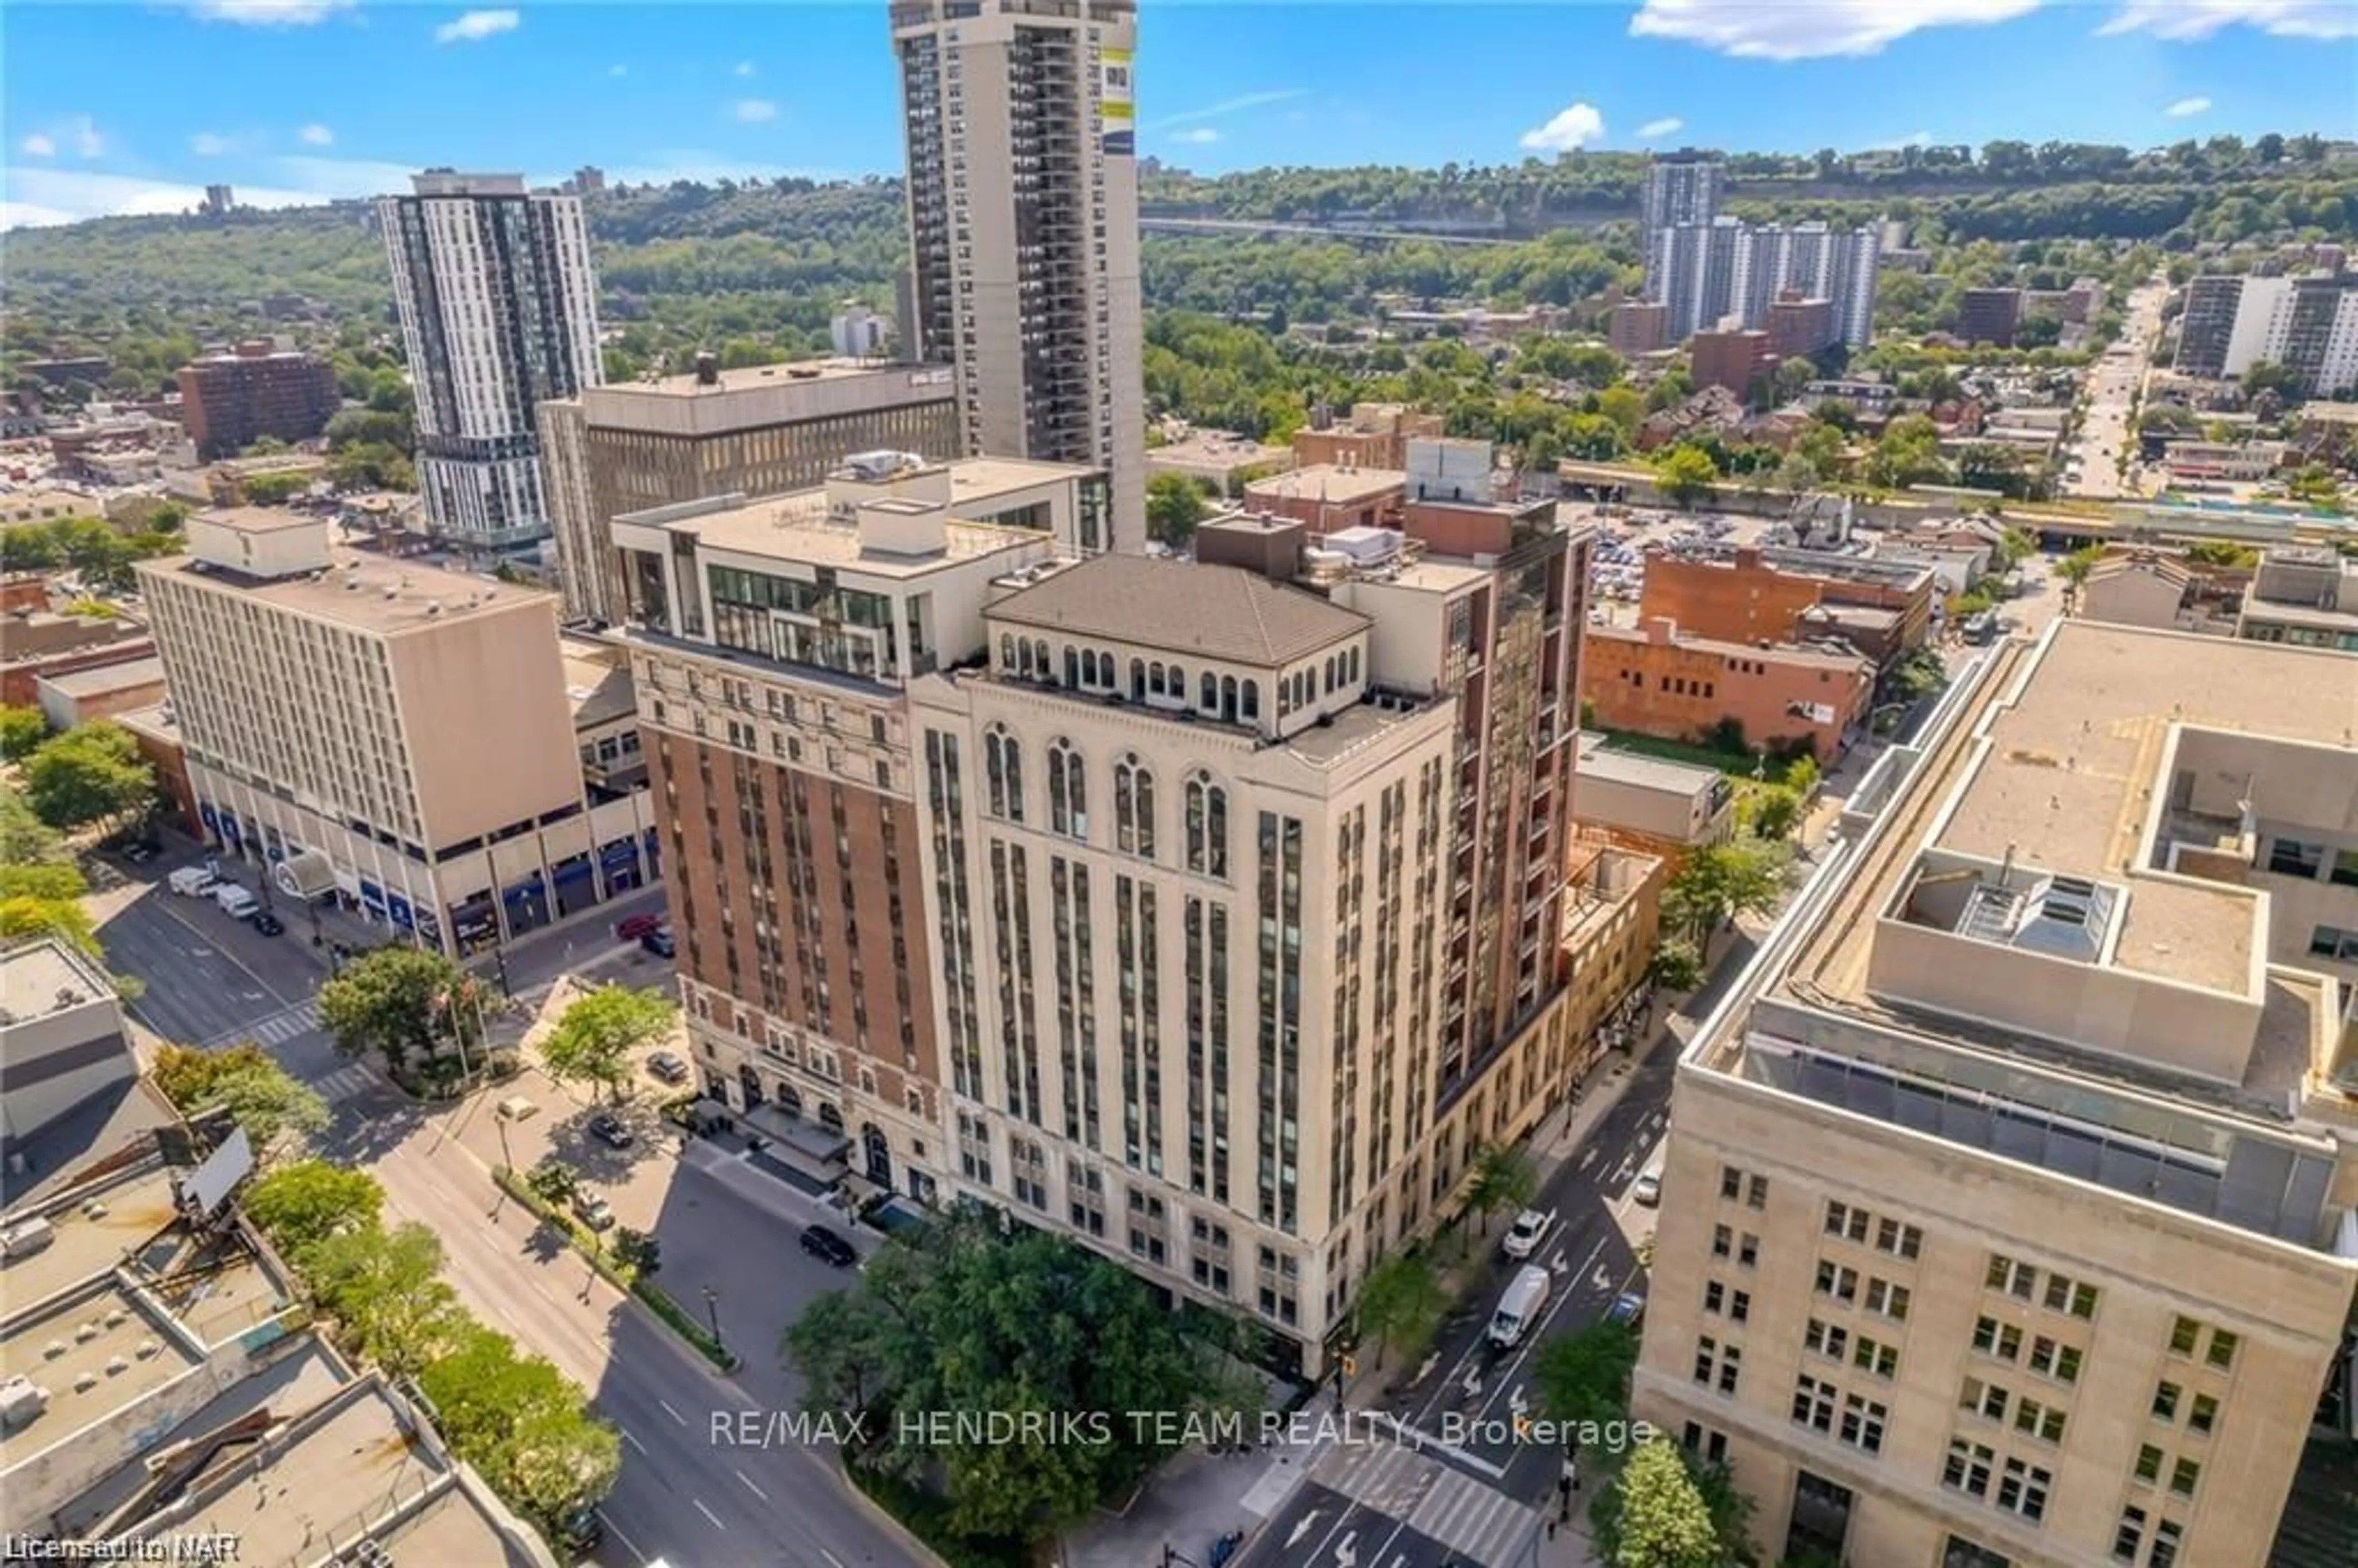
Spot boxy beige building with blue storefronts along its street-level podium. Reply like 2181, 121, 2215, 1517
139, 510, 658, 953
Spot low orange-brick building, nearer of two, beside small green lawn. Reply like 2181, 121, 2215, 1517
1580, 620, 1875, 766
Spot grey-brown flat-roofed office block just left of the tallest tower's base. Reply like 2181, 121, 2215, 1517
540, 354, 960, 623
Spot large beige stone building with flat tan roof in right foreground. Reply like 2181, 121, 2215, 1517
1634, 620, 2358, 1566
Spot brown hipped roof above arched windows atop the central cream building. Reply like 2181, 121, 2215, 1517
988, 556, 1368, 665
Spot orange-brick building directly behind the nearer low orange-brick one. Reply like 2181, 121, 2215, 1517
1641, 549, 1936, 662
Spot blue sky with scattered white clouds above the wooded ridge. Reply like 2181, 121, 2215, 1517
0, 0, 2358, 224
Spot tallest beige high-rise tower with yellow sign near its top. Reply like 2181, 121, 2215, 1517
892, 0, 1146, 552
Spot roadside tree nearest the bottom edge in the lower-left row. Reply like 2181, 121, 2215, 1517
418, 1318, 623, 1526
